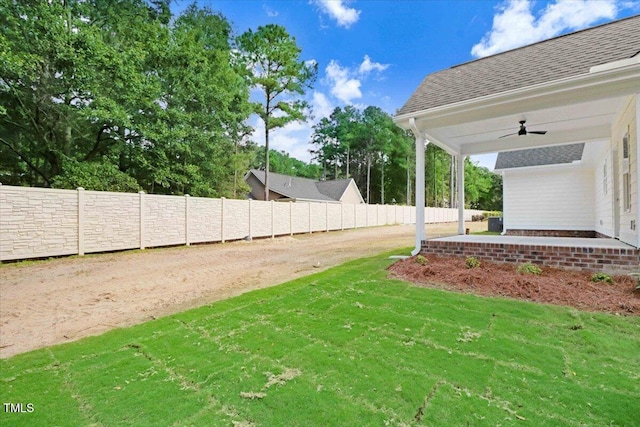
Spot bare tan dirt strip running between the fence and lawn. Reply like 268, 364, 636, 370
0, 223, 486, 358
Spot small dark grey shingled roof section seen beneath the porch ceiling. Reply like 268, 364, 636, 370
495, 143, 584, 170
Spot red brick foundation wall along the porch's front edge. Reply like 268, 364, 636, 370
421, 240, 640, 274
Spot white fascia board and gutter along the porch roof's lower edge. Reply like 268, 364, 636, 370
393, 64, 640, 130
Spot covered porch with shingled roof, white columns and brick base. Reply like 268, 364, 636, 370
394, 17, 640, 271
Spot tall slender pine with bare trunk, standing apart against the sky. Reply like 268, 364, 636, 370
237, 24, 317, 200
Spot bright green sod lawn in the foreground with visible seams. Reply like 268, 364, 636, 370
0, 251, 640, 426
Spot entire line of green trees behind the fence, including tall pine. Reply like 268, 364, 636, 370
0, 0, 501, 209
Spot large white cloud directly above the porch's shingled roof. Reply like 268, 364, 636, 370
471, 0, 618, 57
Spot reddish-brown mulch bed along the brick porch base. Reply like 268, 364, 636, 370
388, 255, 640, 316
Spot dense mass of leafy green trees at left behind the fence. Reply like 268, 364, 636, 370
0, 0, 251, 196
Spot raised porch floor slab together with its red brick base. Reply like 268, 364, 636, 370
421, 235, 640, 274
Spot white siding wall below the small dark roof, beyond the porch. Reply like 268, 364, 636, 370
504, 166, 595, 230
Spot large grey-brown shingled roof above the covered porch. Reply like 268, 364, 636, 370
397, 15, 640, 116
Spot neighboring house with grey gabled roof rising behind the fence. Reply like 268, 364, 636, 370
244, 169, 364, 204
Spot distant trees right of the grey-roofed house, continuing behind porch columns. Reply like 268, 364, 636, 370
311, 106, 502, 210
